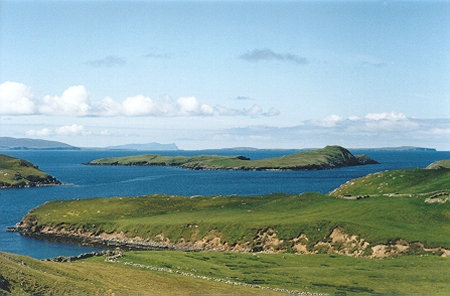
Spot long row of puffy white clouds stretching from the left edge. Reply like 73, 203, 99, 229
0, 82, 280, 117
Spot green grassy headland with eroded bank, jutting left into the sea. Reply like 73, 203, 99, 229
21, 193, 450, 255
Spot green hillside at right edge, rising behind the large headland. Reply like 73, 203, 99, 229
331, 168, 450, 196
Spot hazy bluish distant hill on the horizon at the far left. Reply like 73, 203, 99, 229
0, 137, 80, 150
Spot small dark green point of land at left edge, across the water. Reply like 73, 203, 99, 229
0, 154, 61, 188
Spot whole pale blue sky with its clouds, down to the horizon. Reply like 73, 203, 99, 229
0, 1, 450, 150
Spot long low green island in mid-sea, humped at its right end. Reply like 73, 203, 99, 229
87, 146, 378, 170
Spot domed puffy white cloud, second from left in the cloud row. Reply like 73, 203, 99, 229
39, 85, 91, 116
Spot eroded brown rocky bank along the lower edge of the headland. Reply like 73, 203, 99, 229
9, 220, 450, 258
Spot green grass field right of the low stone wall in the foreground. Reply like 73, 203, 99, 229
113, 251, 450, 295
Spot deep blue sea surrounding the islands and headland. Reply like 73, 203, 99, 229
0, 150, 450, 259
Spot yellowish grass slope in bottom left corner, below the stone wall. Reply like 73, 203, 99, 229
0, 252, 281, 295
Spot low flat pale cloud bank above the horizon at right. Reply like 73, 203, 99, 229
214, 112, 450, 150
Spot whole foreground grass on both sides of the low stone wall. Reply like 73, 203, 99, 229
0, 251, 450, 296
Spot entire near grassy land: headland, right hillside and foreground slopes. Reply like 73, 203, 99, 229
0, 160, 450, 295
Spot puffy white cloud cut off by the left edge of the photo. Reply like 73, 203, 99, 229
0, 81, 35, 115
